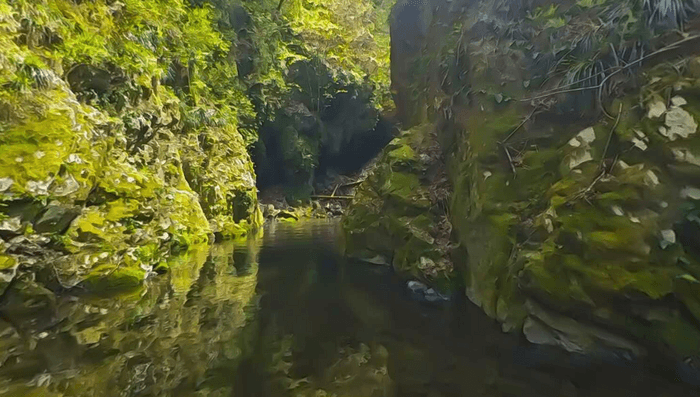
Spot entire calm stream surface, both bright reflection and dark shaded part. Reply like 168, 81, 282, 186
0, 220, 699, 397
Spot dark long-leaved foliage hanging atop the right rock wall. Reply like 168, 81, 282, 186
512, 0, 700, 97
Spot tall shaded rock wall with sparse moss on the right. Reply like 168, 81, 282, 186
346, 0, 700, 362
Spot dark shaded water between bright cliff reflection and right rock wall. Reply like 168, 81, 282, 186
243, 222, 698, 397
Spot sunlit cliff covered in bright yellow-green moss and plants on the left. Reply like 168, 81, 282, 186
0, 0, 261, 291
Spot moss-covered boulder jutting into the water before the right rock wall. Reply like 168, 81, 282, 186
343, 124, 454, 289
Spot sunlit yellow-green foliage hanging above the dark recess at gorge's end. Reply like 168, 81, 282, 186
230, 0, 394, 114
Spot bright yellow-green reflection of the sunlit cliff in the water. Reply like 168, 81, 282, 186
0, 243, 258, 397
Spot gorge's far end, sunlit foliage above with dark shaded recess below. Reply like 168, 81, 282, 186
217, 0, 393, 198
